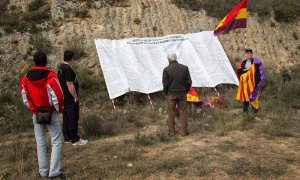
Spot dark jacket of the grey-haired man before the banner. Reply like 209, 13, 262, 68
162, 61, 192, 94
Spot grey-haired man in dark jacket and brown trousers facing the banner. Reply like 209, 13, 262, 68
162, 54, 192, 136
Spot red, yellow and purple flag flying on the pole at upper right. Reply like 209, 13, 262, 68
214, 0, 247, 36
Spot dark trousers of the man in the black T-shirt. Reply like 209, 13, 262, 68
63, 101, 80, 143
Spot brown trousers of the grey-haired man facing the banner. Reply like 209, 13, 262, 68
167, 93, 188, 136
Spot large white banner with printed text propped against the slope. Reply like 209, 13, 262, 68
95, 31, 238, 99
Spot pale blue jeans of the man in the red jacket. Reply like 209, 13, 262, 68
32, 111, 62, 177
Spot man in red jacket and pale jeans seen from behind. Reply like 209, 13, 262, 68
20, 52, 64, 178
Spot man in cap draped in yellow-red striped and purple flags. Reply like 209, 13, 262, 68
236, 49, 264, 113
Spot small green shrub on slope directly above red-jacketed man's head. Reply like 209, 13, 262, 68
29, 34, 52, 53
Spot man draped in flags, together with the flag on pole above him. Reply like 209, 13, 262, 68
214, 0, 264, 113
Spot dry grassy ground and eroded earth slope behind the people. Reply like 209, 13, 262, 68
0, 0, 300, 179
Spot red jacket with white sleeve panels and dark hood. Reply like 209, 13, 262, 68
20, 66, 64, 113
